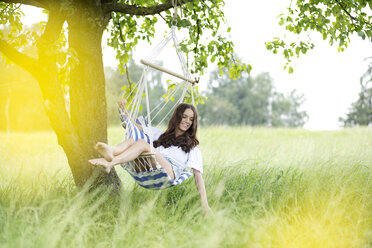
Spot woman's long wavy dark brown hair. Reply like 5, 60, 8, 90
154, 103, 199, 152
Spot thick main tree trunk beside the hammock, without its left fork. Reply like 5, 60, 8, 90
66, 8, 121, 189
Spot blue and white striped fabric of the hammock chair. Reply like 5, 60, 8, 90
119, 108, 193, 190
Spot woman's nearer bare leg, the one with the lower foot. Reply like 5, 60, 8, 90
89, 139, 174, 179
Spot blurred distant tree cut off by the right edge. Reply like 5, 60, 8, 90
339, 58, 372, 127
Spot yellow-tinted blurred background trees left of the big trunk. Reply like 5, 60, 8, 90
0, 22, 51, 131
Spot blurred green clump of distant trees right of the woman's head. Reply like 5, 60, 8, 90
199, 70, 308, 127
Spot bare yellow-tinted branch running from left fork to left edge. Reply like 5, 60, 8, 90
0, 39, 38, 72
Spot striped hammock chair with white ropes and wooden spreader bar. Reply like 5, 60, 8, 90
119, 2, 196, 190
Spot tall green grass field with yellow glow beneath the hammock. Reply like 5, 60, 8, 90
0, 127, 372, 248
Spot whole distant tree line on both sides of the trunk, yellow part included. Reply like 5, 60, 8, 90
0, 56, 308, 131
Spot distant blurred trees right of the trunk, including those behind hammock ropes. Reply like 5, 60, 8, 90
105, 61, 308, 127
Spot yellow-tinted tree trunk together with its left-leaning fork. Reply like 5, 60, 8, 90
30, 2, 121, 192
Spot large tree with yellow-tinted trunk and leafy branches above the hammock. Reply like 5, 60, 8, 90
0, 0, 251, 189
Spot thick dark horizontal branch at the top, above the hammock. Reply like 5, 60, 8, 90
105, 0, 193, 16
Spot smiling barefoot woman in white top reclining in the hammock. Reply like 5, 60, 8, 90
89, 102, 210, 213
